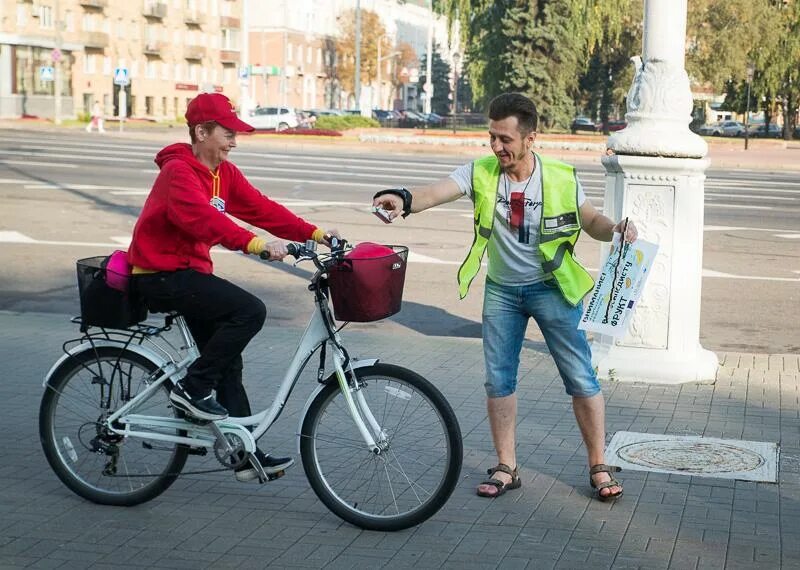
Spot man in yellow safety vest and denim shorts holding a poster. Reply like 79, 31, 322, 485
373, 93, 637, 500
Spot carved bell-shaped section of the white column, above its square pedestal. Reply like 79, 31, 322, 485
608, 56, 708, 158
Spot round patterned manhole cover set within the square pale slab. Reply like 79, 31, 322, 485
617, 440, 766, 473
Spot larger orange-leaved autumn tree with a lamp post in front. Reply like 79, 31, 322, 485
336, 9, 392, 93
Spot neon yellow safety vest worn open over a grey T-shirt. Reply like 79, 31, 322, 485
458, 154, 594, 306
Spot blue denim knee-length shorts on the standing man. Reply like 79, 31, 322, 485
483, 279, 600, 398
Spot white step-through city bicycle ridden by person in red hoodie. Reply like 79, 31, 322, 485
39, 237, 463, 531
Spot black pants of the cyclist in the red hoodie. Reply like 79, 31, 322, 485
135, 269, 267, 417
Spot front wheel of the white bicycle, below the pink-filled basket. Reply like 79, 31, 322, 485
300, 364, 463, 531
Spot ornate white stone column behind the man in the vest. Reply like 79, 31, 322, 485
592, 0, 718, 384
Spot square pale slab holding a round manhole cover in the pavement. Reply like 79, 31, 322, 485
606, 431, 778, 482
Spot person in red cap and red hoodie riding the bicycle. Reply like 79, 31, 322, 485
128, 93, 338, 481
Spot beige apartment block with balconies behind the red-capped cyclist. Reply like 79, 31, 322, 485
0, 0, 243, 120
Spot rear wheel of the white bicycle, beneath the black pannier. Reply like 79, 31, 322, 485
39, 347, 189, 506
